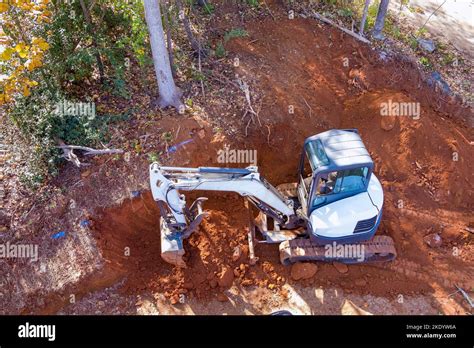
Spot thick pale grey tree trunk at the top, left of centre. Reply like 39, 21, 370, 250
143, 0, 183, 110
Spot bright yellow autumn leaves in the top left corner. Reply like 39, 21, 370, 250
0, 0, 51, 105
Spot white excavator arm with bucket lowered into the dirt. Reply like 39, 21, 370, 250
150, 163, 297, 267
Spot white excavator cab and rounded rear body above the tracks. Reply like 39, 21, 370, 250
298, 129, 383, 244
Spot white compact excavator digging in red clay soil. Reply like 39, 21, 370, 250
150, 129, 396, 267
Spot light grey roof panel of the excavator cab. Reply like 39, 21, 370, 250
305, 129, 374, 170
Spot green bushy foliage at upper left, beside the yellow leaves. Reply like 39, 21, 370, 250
0, 0, 152, 188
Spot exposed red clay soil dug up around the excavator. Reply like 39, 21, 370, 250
93, 15, 474, 303
